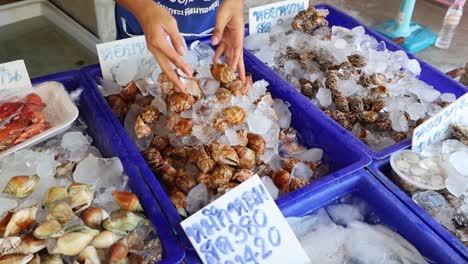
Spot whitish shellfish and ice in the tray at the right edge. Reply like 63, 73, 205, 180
391, 125, 468, 245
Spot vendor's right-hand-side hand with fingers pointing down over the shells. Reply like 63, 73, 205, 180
211, 0, 245, 81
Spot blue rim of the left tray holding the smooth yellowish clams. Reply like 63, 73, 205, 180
32, 71, 184, 264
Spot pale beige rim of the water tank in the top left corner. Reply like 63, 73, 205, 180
0, 0, 101, 54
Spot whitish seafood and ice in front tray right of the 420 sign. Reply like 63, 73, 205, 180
287, 197, 428, 264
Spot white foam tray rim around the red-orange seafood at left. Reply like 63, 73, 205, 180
0, 82, 79, 159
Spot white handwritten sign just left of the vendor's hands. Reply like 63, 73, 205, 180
96, 36, 156, 82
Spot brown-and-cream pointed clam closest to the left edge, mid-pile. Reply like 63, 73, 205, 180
3, 206, 39, 237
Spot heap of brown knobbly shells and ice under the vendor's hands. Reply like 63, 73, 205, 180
98, 42, 328, 216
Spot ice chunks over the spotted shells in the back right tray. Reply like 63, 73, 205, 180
245, 11, 455, 151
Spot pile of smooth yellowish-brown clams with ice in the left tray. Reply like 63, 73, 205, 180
0, 119, 162, 263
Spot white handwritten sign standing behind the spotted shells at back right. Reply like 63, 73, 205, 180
249, 0, 309, 34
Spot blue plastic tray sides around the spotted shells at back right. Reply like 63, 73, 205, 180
244, 4, 468, 159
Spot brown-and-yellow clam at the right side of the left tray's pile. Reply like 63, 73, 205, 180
102, 210, 143, 235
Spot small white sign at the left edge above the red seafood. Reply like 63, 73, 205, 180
0, 60, 32, 91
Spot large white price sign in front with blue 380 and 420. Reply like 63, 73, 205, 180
182, 175, 310, 264
